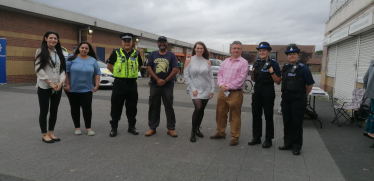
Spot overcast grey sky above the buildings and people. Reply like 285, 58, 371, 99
30, 0, 330, 52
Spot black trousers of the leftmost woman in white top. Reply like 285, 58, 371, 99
38, 87, 62, 134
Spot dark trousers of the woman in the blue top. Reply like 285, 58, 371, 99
65, 92, 92, 129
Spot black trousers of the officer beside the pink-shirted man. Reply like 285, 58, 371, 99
252, 84, 275, 139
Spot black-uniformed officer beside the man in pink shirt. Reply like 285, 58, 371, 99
248, 42, 281, 148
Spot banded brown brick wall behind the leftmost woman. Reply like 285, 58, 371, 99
0, 10, 78, 84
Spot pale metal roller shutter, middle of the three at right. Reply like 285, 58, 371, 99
334, 37, 357, 99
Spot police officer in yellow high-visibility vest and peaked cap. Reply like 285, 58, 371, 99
107, 33, 142, 137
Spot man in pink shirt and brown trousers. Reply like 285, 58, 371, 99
210, 41, 248, 146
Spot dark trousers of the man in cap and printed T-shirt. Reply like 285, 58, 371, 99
148, 86, 175, 130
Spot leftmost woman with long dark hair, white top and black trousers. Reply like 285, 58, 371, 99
35, 31, 66, 143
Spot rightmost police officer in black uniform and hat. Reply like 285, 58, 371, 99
279, 46, 314, 155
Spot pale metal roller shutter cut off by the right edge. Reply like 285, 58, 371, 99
357, 32, 374, 83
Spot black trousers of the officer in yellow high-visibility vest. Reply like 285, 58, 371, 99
110, 78, 138, 127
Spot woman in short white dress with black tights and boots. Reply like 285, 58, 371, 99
184, 42, 214, 142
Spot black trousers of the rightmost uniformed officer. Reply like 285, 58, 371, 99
281, 93, 307, 150
